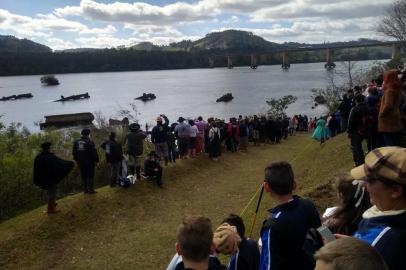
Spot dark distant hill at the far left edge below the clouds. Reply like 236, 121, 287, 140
0, 35, 52, 53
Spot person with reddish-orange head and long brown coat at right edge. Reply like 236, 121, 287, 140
378, 69, 402, 146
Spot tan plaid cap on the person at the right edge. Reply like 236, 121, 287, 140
351, 146, 406, 185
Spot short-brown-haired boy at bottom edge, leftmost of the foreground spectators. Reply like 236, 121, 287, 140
166, 216, 226, 270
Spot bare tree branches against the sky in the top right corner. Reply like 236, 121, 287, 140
377, 0, 406, 41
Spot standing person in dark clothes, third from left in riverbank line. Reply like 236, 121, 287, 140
101, 132, 123, 187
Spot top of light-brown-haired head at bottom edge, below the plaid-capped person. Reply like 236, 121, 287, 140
314, 237, 388, 270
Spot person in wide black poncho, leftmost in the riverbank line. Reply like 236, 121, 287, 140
34, 142, 74, 214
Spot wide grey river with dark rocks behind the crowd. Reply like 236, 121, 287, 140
0, 61, 384, 131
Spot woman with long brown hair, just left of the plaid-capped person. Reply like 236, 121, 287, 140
323, 175, 371, 235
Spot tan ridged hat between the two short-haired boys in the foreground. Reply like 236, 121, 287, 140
213, 223, 241, 254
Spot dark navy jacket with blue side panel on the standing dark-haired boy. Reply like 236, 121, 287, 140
259, 196, 321, 270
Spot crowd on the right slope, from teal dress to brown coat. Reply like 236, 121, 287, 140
313, 70, 406, 166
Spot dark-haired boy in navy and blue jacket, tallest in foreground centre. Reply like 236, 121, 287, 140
260, 161, 321, 270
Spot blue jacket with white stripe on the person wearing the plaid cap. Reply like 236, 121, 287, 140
354, 210, 406, 270
